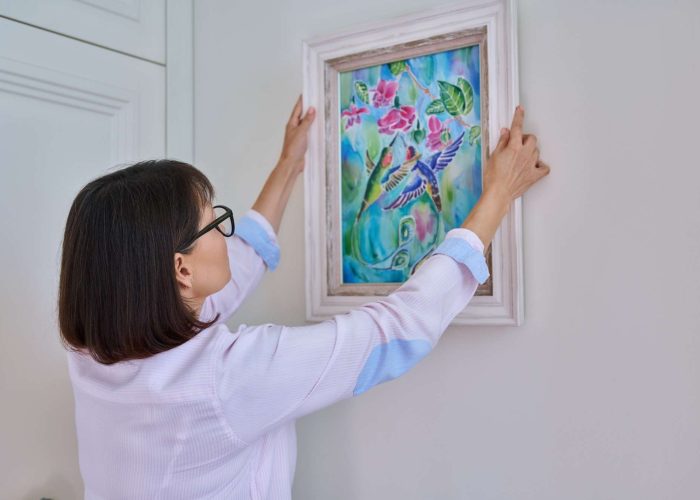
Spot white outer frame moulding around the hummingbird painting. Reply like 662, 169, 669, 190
302, 0, 523, 325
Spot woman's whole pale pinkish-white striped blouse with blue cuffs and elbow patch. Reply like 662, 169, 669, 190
68, 209, 489, 500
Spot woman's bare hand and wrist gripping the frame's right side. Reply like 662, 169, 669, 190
462, 106, 549, 249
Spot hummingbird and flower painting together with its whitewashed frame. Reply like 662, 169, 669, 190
303, 0, 523, 325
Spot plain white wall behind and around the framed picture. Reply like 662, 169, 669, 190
195, 0, 700, 500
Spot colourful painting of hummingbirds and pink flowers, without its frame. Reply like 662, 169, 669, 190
339, 45, 482, 283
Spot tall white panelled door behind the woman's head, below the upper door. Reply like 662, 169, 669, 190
0, 13, 166, 499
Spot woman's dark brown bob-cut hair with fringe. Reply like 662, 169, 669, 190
58, 159, 219, 364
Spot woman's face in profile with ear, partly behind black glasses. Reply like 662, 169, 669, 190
175, 204, 231, 312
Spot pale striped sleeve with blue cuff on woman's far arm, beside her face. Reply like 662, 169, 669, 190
199, 208, 280, 324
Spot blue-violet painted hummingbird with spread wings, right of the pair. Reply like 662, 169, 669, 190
383, 132, 464, 211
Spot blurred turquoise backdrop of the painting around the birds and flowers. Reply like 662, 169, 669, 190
339, 45, 482, 283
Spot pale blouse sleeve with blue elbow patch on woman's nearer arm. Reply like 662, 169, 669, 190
214, 228, 489, 442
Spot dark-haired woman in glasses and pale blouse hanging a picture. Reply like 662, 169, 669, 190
59, 98, 549, 499
